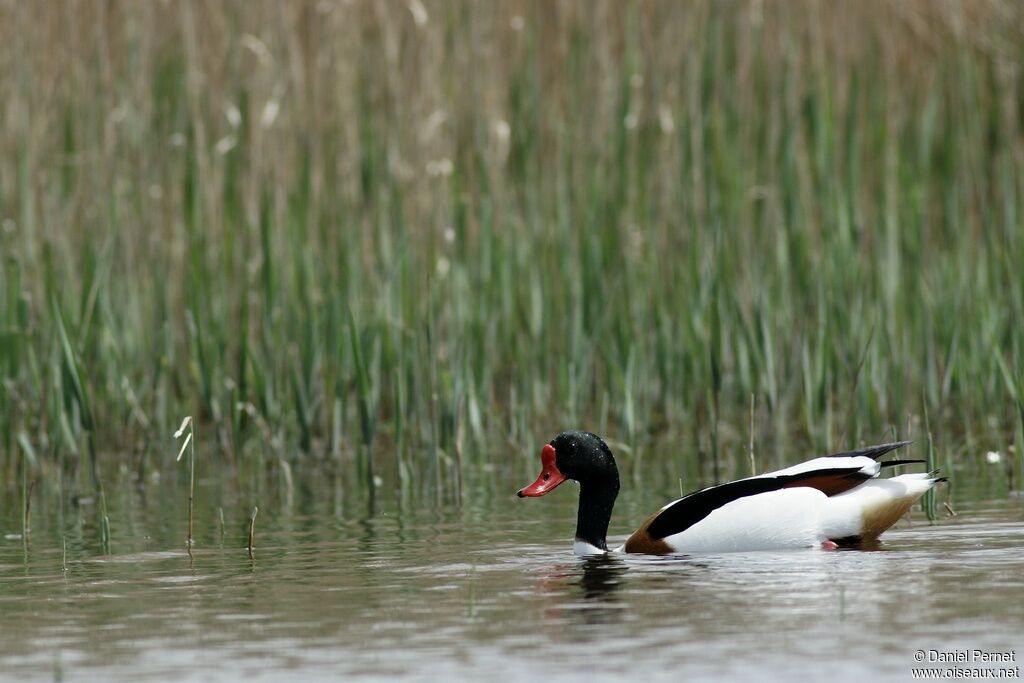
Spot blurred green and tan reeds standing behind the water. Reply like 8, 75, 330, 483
0, 0, 1024, 507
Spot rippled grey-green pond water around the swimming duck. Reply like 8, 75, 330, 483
0, 479, 1024, 681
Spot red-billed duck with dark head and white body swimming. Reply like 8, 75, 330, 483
516, 431, 946, 556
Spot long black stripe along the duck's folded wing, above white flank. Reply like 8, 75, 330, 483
647, 467, 871, 539
